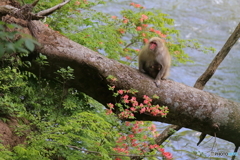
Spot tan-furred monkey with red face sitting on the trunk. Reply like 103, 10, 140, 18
138, 37, 171, 87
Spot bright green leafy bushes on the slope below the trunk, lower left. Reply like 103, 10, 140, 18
0, 49, 118, 159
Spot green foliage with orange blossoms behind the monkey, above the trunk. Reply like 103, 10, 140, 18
35, 0, 213, 65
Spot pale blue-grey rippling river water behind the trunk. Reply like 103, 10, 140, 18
94, 0, 240, 160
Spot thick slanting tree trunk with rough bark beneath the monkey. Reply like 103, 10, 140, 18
1, 0, 240, 148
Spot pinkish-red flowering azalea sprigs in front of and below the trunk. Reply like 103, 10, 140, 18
107, 75, 172, 159
